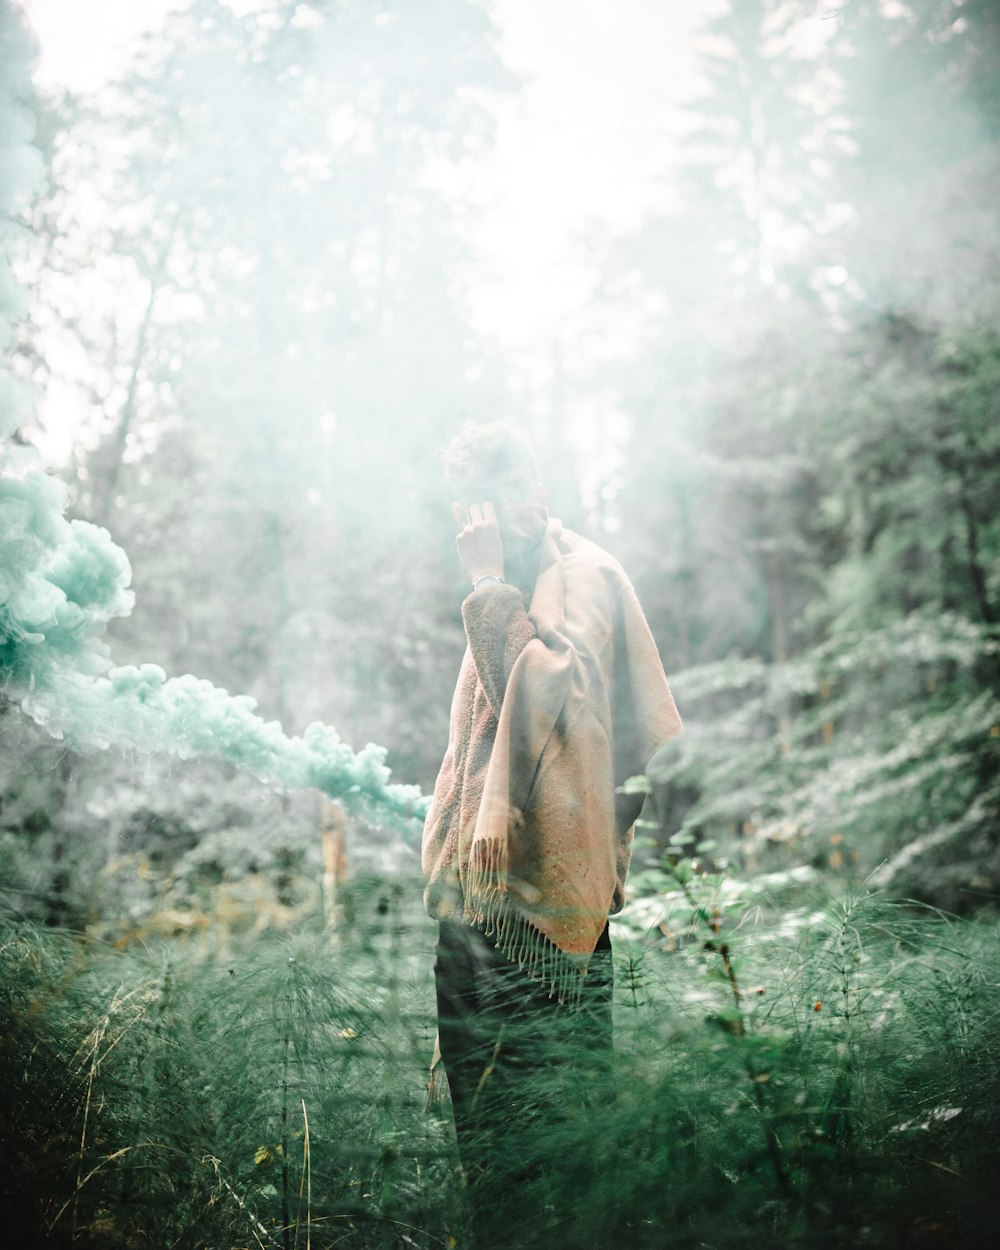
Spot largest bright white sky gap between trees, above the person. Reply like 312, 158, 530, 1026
480, 0, 714, 339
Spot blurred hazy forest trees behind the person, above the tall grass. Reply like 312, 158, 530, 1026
0, 0, 1000, 930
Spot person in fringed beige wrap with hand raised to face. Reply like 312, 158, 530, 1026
423, 425, 681, 1240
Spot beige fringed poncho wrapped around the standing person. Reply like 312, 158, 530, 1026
423, 520, 681, 998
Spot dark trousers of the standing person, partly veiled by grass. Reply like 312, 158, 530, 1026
434, 920, 614, 1244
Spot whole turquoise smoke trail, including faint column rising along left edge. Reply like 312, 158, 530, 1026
0, 0, 426, 835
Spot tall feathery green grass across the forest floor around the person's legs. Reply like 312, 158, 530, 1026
0, 881, 1000, 1250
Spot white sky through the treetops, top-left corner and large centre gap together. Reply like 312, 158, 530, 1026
23, 0, 718, 472
